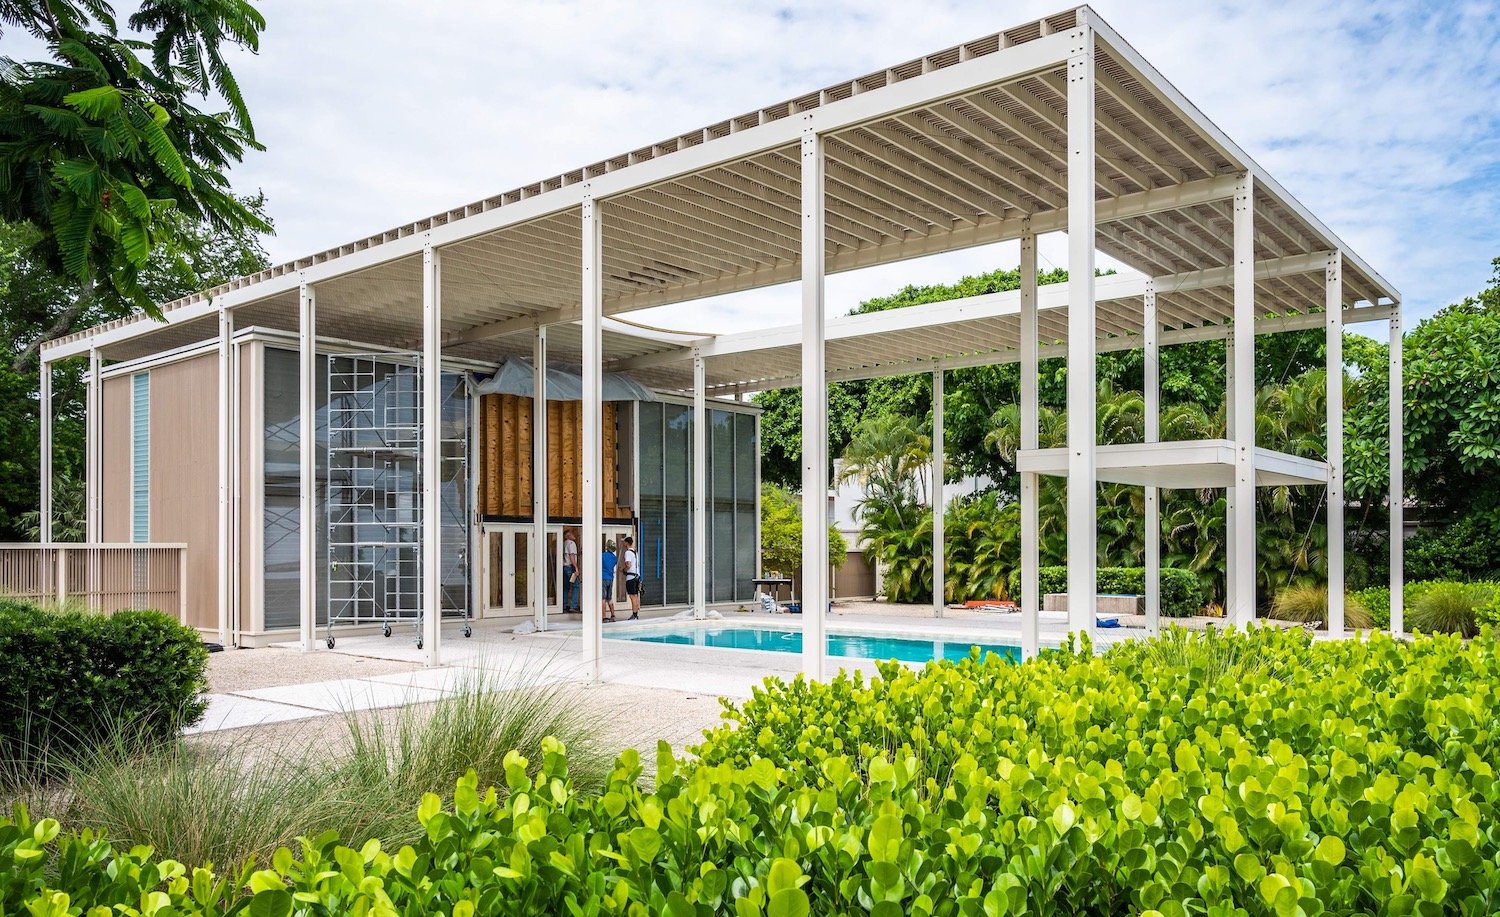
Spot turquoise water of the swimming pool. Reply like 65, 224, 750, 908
605, 624, 1022, 662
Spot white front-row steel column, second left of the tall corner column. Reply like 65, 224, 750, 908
578, 195, 603, 681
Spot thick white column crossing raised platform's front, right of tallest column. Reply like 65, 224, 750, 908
1226, 173, 1256, 627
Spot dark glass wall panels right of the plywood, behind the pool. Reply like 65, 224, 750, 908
636, 402, 759, 605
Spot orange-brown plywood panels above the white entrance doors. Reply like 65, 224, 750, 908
479, 395, 632, 519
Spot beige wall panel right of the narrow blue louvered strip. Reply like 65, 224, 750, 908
150, 354, 219, 627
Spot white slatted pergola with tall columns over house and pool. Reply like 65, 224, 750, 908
42, 6, 1401, 677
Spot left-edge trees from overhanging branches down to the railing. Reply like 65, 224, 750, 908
0, 0, 270, 540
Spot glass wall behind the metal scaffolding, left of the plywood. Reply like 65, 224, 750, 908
261, 347, 470, 630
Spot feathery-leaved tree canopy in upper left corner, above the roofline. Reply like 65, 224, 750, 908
0, 0, 270, 372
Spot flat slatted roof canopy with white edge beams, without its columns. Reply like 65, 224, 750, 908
44, 8, 1400, 378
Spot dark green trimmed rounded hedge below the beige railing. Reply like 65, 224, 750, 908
0, 600, 209, 765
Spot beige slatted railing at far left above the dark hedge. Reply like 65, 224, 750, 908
0, 543, 188, 623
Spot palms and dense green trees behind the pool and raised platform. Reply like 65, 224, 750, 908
786, 260, 1500, 605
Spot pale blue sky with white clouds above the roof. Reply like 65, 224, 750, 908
6, 0, 1500, 332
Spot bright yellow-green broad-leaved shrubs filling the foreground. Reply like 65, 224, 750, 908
0, 629, 1500, 917
